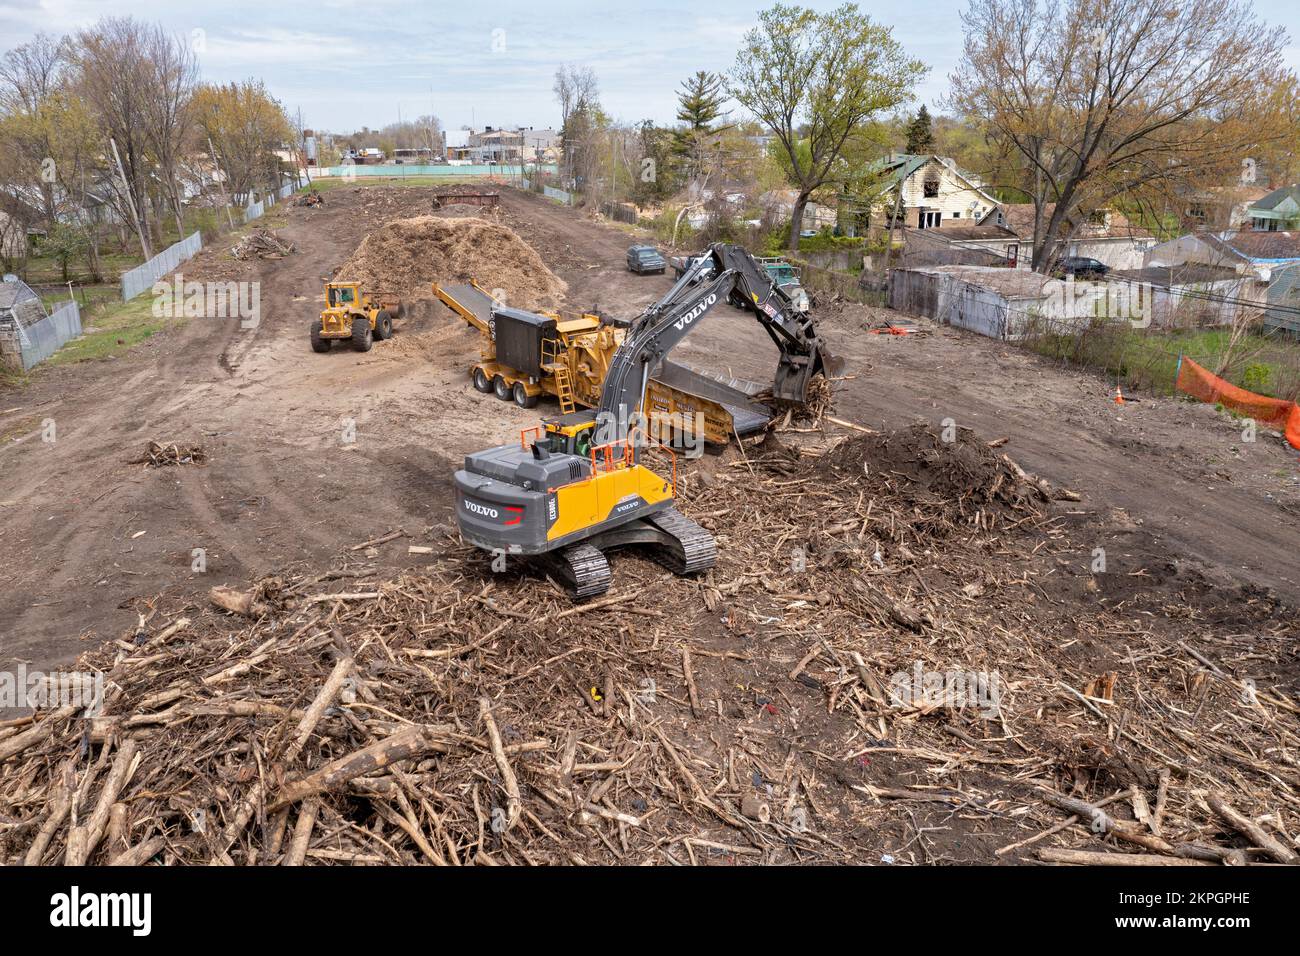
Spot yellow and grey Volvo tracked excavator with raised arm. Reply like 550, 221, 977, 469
455, 243, 827, 598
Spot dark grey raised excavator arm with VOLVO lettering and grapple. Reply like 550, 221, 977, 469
598, 243, 827, 438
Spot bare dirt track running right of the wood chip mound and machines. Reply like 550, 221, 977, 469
491, 188, 1300, 602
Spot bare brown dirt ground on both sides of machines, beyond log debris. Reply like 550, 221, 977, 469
0, 187, 1300, 681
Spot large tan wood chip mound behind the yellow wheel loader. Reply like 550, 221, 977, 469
335, 216, 567, 310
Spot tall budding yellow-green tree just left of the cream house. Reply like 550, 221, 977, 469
731, 3, 926, 251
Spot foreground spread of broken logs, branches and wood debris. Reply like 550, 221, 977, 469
0, 429, 1300, 865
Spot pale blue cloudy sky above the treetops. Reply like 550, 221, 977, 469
0, 0, 1300, 133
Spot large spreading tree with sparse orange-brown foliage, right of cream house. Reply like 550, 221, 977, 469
952, 0, 1286, 272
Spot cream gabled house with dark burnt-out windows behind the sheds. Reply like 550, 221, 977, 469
872, 153, 998, 229
